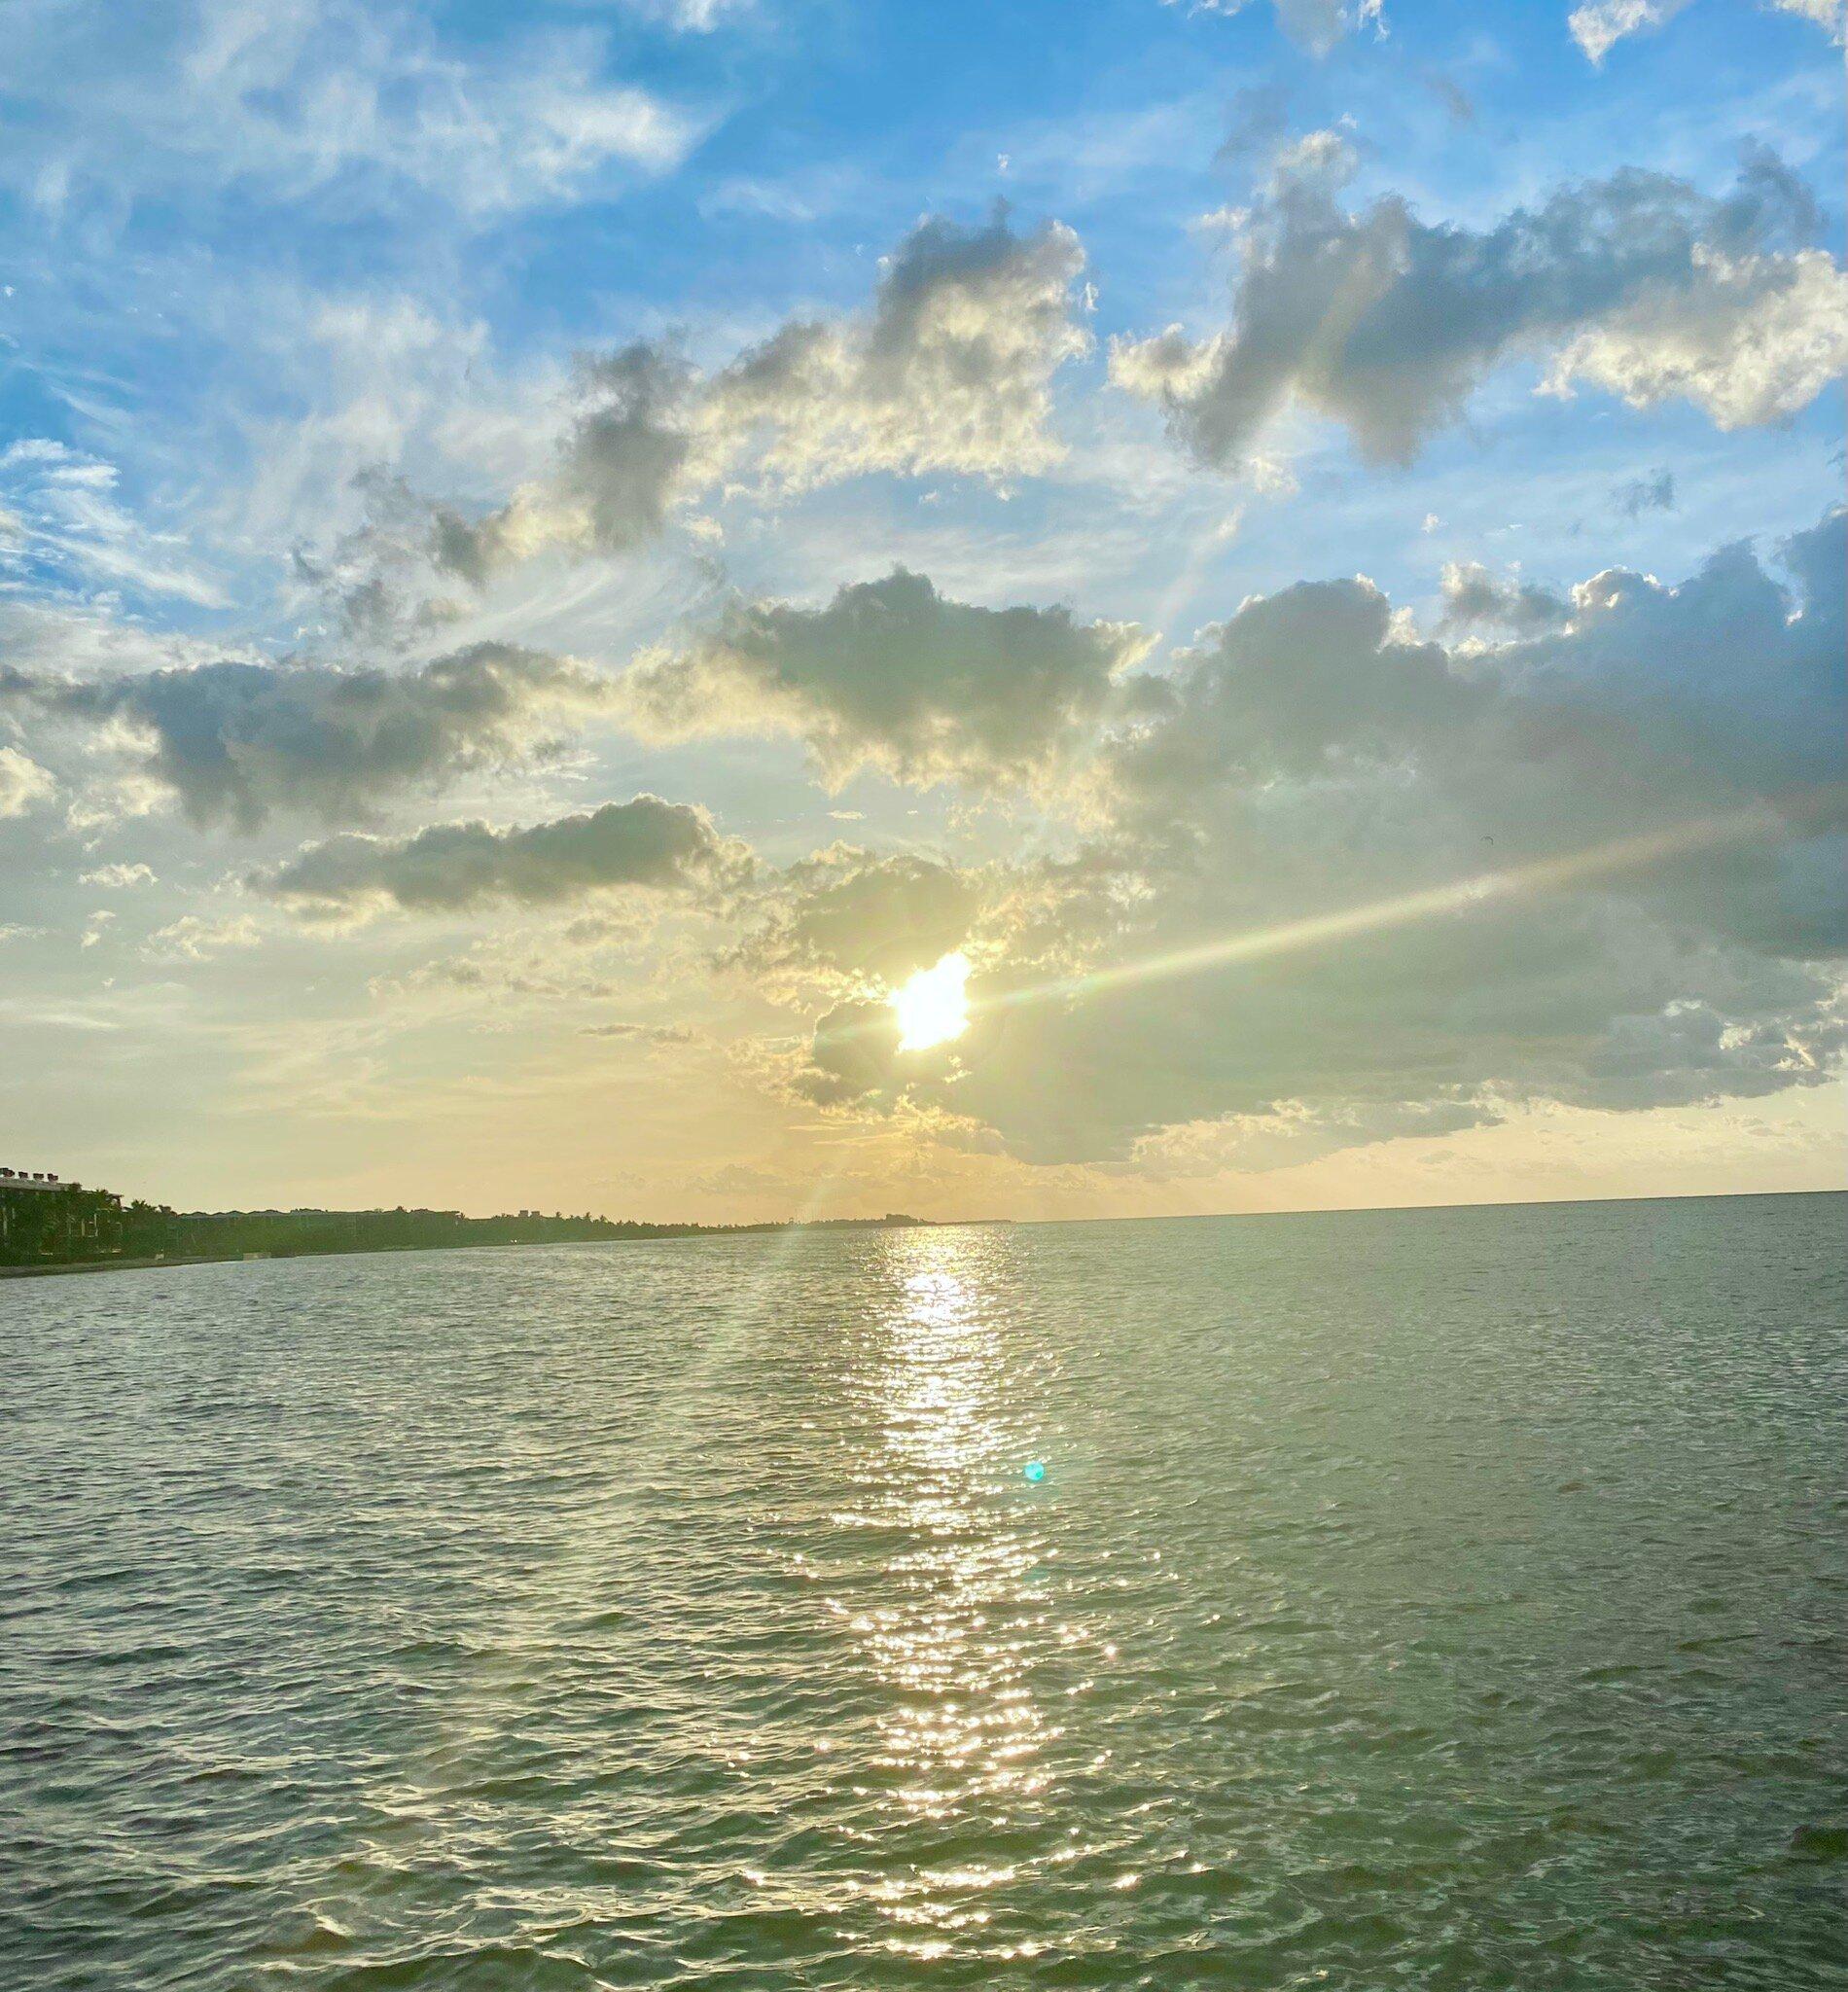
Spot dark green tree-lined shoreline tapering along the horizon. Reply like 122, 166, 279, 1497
0, 1175, 930, 1279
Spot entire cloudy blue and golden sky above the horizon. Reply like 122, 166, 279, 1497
0, 0, 1848, 1221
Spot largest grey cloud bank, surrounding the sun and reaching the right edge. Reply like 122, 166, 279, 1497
741, 514, 1848, 1173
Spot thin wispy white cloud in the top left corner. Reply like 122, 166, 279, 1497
8, 0, 699, 219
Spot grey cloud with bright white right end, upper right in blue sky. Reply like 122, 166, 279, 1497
1111, 133, 1848, 468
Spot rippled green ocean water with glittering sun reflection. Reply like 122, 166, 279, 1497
0, 1197, 1848, 1992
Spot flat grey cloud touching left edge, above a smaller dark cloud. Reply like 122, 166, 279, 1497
0, 644, 607, 831
